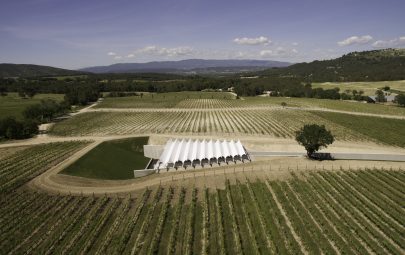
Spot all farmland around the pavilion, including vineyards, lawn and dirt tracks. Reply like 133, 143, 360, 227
0, 92, 405, 255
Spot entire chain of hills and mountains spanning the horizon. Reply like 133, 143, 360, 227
0, 49, 405, 82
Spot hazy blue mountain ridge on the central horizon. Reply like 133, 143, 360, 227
79, 59, 291, 74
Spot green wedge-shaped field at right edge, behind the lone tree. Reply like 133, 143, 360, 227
312, 111, 405, 147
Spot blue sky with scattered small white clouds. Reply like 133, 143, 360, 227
0, 0, 405, 69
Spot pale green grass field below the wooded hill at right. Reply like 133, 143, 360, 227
312, 81, 405, 96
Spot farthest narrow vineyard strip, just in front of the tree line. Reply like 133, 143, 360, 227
95, 92, 405, 116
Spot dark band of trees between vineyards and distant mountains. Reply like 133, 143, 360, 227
0, 74, 404, 105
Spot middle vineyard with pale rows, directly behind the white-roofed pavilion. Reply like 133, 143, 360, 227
51, 109, 366, 140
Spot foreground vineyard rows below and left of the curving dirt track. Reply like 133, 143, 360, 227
0, 142, 405, 254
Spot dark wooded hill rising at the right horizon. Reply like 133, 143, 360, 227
253, 49, 405, 82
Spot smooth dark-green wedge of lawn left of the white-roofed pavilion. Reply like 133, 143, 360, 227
61, 137, 149, 180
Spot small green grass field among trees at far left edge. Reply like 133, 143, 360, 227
0, 93, 64, 119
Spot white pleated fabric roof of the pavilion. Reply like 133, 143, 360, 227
156, 139, 247, 167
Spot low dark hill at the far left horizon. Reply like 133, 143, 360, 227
0, 64, 84, 77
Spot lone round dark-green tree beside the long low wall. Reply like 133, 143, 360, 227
295, 124, 335, 158
